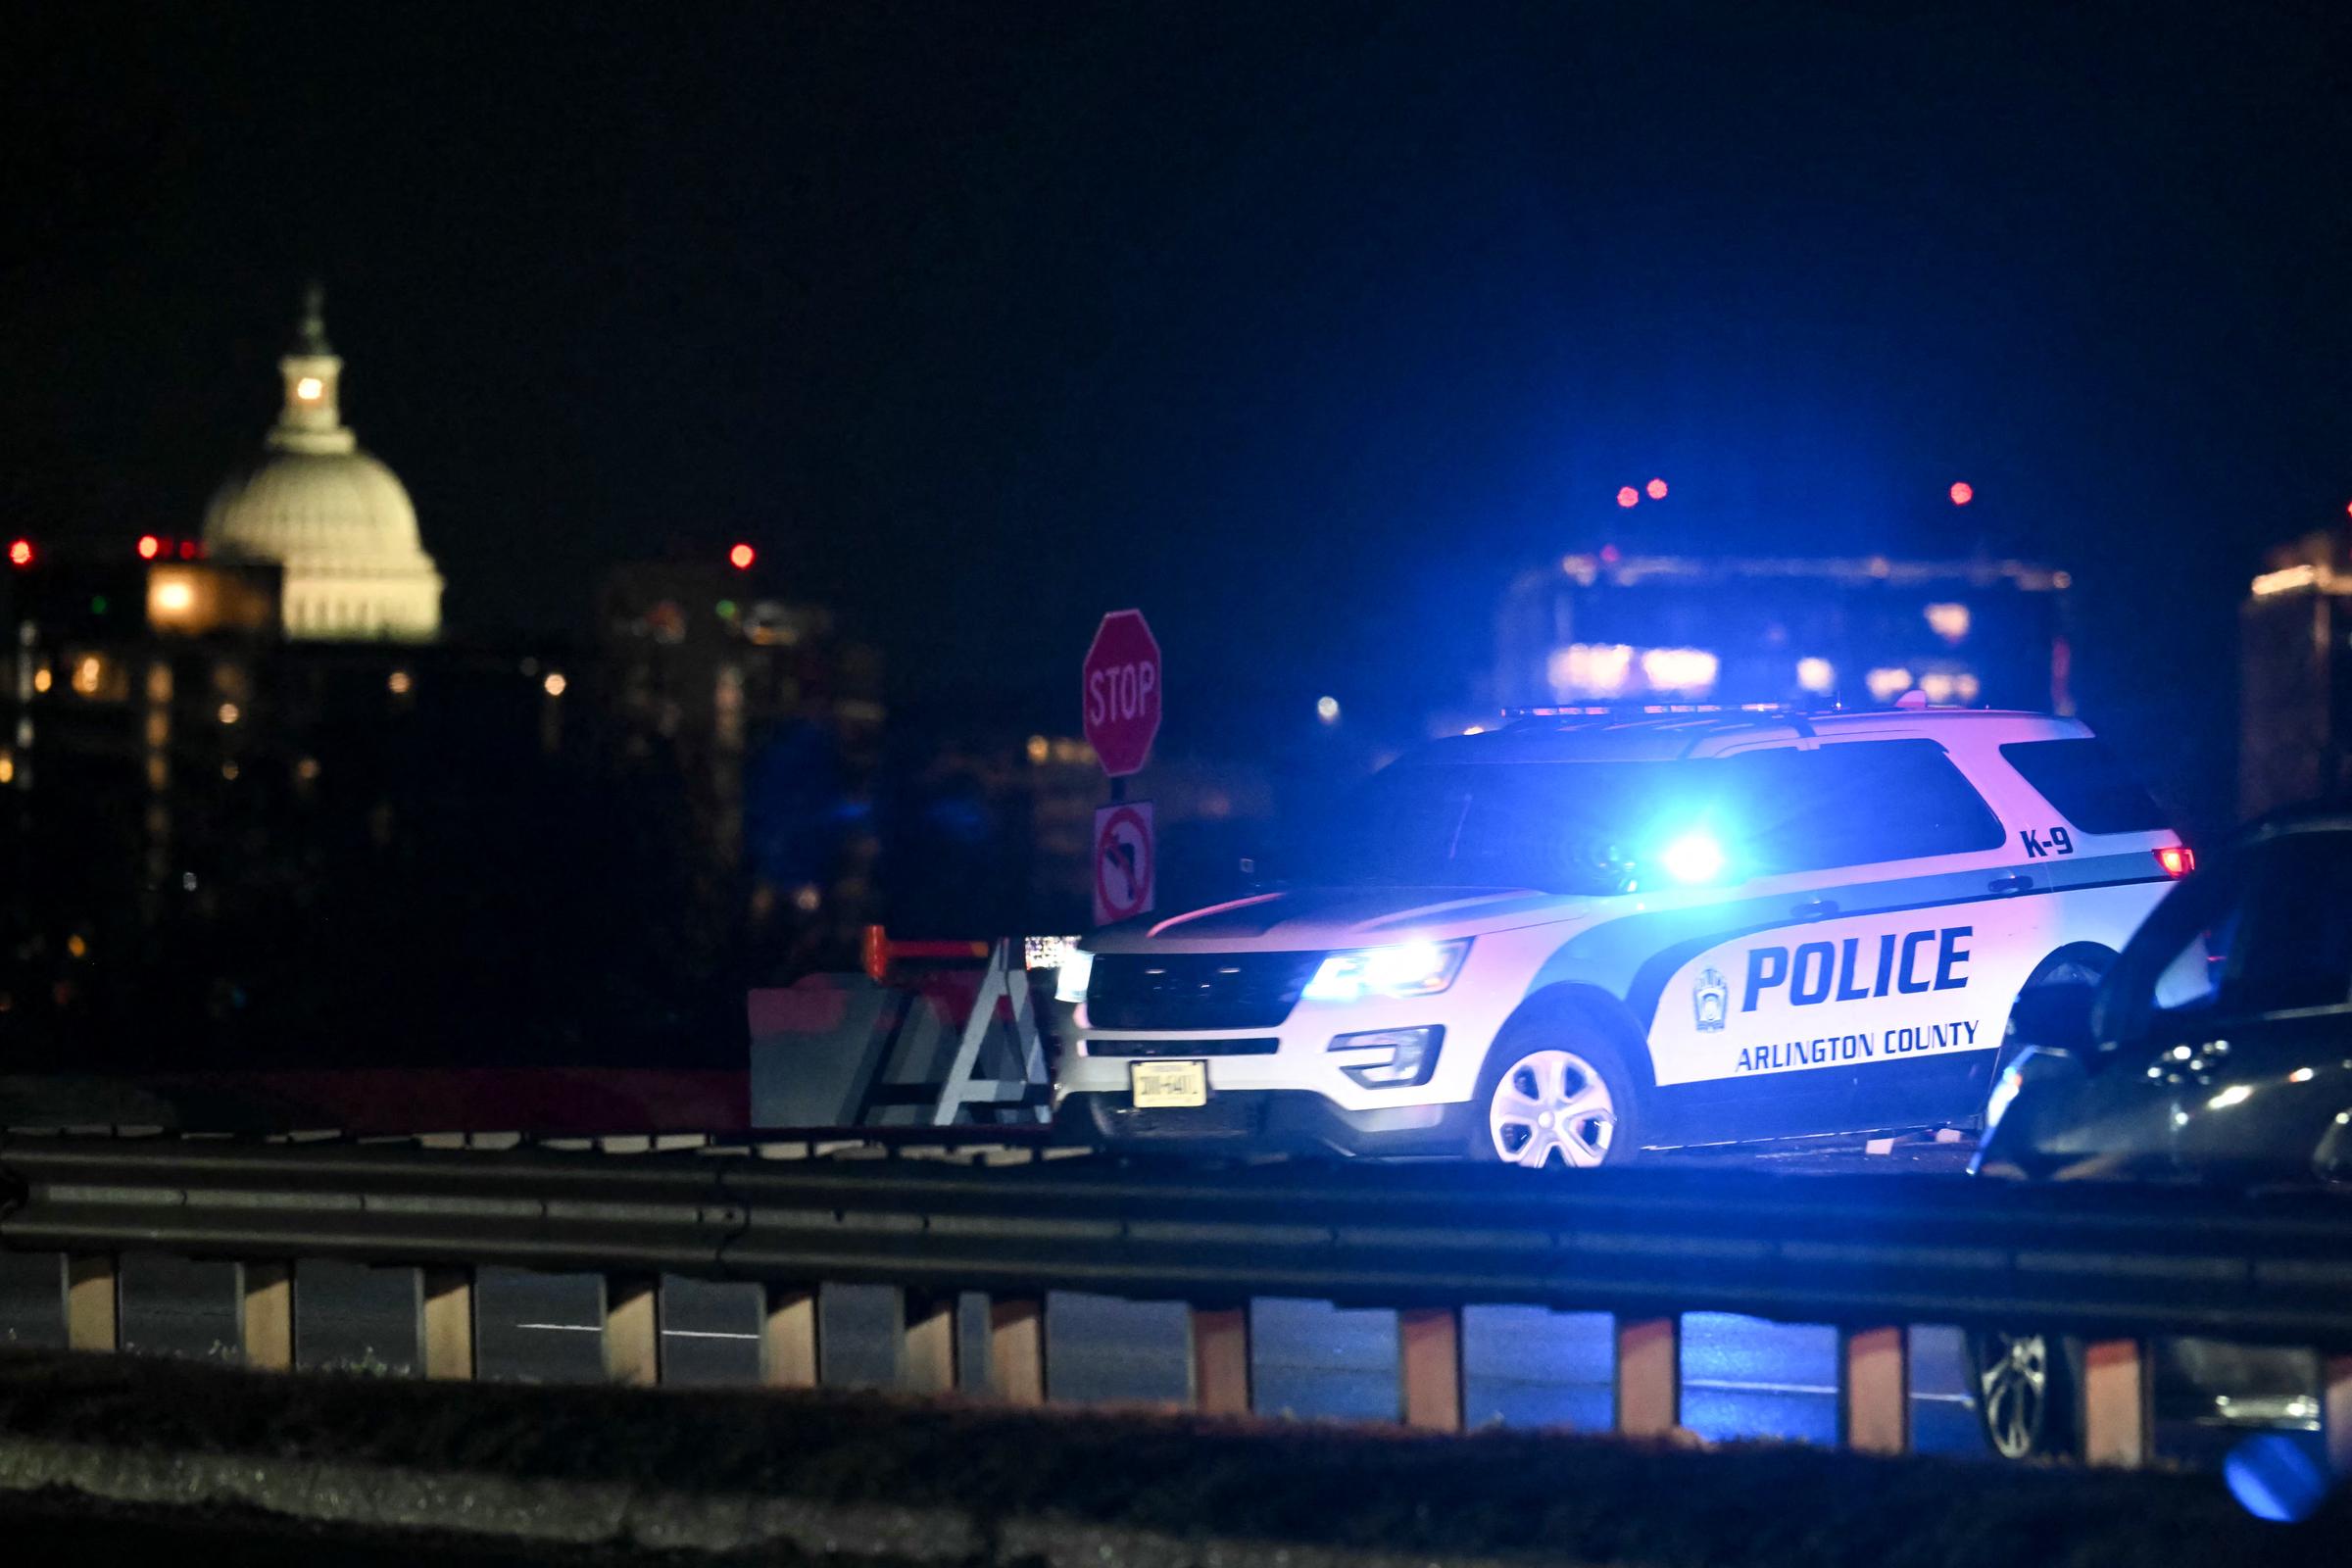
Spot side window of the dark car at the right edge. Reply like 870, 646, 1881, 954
2225, 832, 2352, 1013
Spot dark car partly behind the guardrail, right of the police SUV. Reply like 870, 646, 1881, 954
1971, 807, 2352, 1457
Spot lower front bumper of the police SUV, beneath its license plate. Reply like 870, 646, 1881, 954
1054, 1089, 1475, 1156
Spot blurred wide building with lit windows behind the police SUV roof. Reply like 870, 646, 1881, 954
1489, 550, 2075, 714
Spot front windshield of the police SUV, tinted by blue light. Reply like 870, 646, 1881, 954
1300, 761, 1724, 894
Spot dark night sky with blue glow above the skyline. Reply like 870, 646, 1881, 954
0, 2, 2352, 811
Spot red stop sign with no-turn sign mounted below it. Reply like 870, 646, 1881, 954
1077, 609, 1162, 926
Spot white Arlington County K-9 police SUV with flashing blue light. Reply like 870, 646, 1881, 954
1054, 710, 2189, 1166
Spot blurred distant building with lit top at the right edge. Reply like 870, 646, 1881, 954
2236, 529, 2352, 815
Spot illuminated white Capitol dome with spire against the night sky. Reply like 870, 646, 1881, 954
205, 287, 442, 642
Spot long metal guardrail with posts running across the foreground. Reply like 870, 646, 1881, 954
0, 1138, 2352, 1472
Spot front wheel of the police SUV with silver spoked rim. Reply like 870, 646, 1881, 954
1470, 1015, 1640, 1171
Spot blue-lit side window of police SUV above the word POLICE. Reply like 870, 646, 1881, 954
1727, 741, 2006, 872
